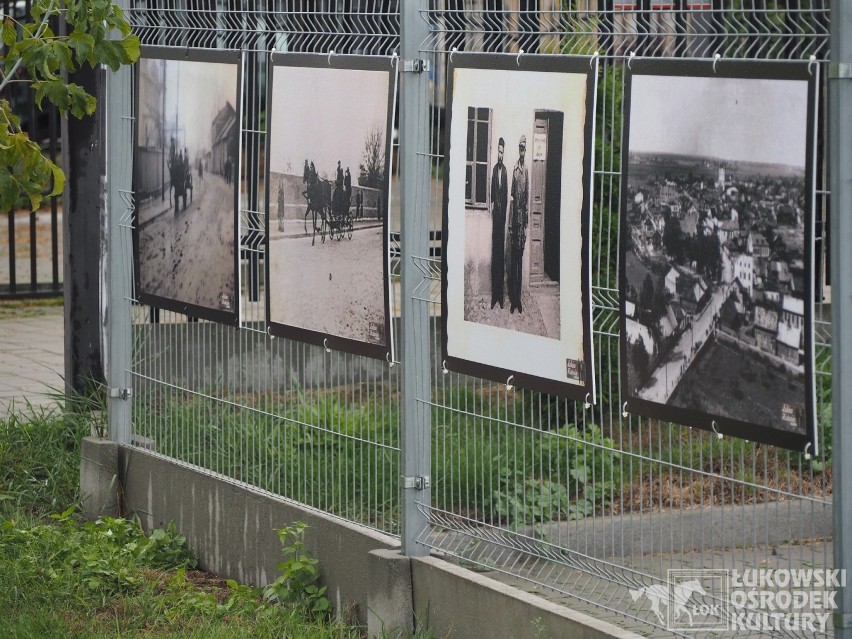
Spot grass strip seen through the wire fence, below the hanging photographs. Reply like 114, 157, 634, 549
134, 387, 618, 533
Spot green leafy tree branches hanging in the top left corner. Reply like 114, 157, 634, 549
0, 0, 140, 211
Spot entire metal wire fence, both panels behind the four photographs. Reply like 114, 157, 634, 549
121, 0, 832, 636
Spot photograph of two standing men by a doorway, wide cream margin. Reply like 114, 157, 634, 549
443, 54, 595, 399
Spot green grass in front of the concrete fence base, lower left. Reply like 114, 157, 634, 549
0, 410, 376, 639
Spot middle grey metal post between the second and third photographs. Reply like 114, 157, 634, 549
399, 0, 432, 556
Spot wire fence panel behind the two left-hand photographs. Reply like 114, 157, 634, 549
129, 0, 400, 534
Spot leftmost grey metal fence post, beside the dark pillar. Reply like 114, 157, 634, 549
105, 8, 133, 444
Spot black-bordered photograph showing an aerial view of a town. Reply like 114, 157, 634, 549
621, 60, 815, 449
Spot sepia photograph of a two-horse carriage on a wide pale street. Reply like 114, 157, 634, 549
267, 54, 395, 358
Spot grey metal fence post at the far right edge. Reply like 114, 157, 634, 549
828, 2, 852, 639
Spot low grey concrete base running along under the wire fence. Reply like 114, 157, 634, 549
106, 446, 638, 639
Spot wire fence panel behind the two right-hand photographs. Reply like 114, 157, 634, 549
421, 0, 832, 636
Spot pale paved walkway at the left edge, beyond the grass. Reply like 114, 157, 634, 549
0, 303, 65, 419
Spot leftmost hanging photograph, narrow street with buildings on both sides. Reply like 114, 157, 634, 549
134, 48, 240, 324
